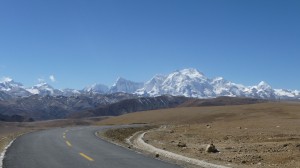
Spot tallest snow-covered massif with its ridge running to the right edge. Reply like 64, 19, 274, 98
135, 69, 300, 99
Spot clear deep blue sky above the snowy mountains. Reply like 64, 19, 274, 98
0, 0, 300, 90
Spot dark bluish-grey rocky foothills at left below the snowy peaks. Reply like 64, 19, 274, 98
0, 93, 137, 120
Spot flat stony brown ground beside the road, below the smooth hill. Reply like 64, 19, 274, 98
144, 122, 300, 168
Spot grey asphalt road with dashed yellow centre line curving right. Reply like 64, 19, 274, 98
3, 127, 179, 168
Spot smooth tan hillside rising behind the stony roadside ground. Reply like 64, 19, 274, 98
101, 102, 300, 124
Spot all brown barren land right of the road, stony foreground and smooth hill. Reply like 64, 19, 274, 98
101, 103, 300, 167
